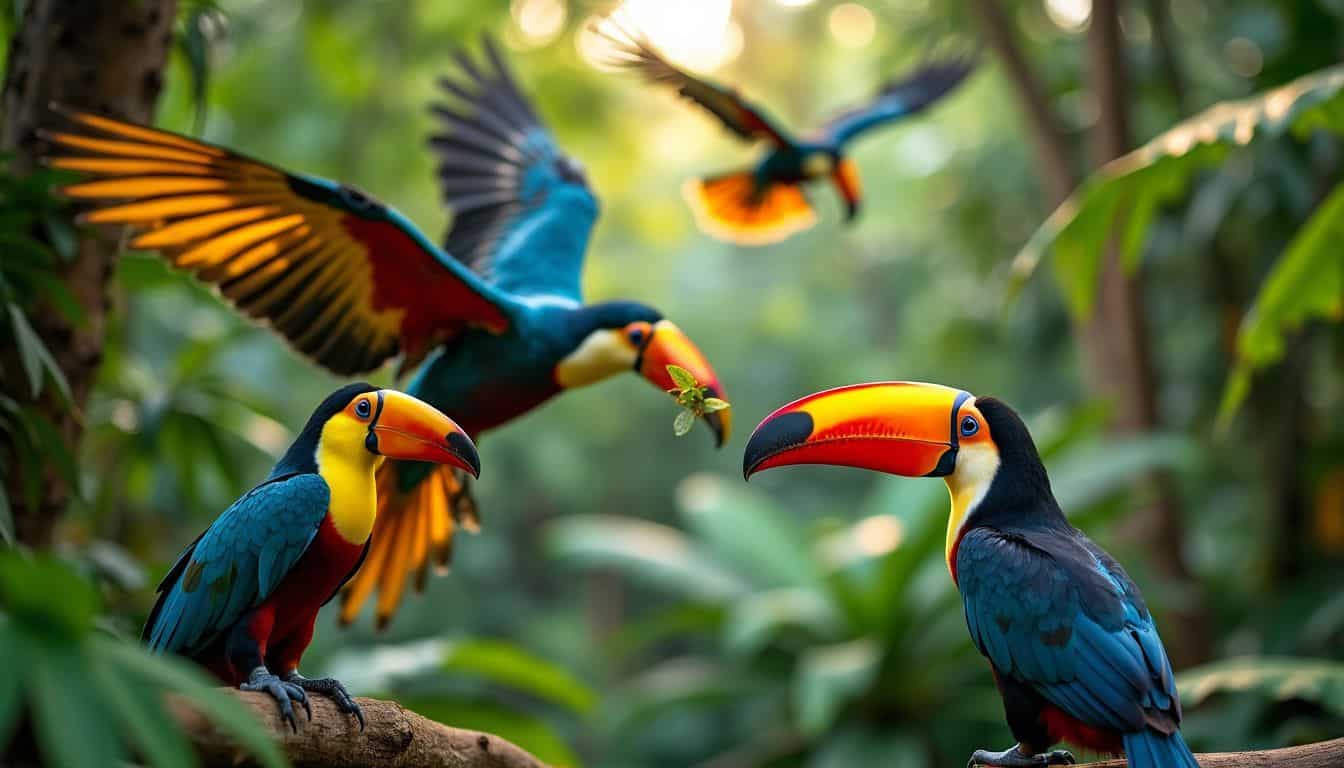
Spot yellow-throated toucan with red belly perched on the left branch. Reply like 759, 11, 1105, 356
142, 383, 480, 729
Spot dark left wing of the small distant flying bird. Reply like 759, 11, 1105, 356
594, 20, 793, 147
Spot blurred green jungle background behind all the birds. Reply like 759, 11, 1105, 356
0, 0, 1344, 768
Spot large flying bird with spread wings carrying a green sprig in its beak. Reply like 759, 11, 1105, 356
47, 40, 731, 625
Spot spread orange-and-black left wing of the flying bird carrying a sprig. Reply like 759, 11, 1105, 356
47, 113, 509, 374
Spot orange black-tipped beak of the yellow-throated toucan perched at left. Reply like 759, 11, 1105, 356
368, 389, 481, 477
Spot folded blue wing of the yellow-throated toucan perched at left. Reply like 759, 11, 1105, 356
144, 473, 331, 654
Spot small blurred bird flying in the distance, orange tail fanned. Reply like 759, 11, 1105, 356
595, 29, 974, 245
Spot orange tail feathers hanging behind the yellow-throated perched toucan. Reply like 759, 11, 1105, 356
340, 461, 480, 629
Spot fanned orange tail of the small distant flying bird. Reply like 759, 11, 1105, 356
683, 171, 817, 245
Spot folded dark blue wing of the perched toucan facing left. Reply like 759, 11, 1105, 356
957, 529, 1180, 733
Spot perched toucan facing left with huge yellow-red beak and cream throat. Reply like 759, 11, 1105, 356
743, 382, 1199, 768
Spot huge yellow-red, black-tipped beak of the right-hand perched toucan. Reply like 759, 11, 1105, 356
742, 382, 970, 477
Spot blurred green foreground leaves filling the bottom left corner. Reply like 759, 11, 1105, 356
0, 550, 285, 768
